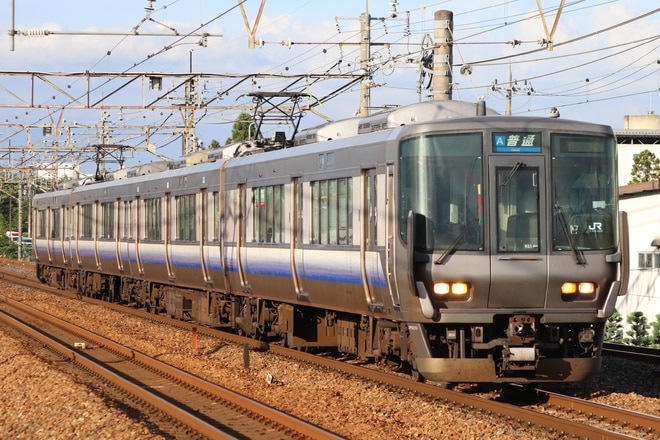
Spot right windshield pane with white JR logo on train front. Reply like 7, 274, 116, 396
550, 134, 618, 251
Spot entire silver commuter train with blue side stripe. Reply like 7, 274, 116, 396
32, 101, 628, 383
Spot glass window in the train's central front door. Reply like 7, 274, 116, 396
496, 166, 539, 252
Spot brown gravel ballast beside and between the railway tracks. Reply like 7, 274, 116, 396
0, 260, 660, 439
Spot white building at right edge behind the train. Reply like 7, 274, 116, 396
615, 113, 660, 324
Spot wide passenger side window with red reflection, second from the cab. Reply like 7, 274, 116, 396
252, 185, 284, 243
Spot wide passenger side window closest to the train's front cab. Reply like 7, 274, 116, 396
310, 177, 353, 246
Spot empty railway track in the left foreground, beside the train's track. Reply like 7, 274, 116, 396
0, 296, 339, 439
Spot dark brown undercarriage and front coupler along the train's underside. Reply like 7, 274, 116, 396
37, 265, 605, 383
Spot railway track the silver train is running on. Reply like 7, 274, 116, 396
1, 266, 660, 439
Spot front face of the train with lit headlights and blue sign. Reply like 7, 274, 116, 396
396, 116, 627, 383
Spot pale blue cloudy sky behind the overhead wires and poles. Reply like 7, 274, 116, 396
0, 0, 660, 167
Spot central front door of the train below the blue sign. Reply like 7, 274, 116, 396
488, 156, 548, 309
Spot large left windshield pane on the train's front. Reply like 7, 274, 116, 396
399, 133, 484, 250
